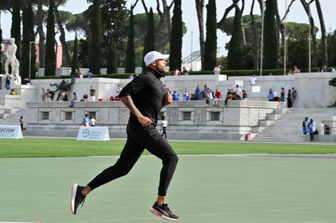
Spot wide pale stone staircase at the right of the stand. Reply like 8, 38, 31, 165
253, 108, 336, 143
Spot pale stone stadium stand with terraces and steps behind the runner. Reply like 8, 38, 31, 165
0, 73, 336, 142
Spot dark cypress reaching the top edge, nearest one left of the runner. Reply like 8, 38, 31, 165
89, 0, 103, 74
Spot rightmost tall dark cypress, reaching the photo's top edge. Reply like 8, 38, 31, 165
263, 0, 279, 69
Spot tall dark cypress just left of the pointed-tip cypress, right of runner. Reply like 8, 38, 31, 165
202, 0, 217, 70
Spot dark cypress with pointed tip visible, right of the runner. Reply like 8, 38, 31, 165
227, 7, 244, 69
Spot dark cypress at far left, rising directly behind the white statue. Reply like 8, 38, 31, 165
11, 0, 22, 60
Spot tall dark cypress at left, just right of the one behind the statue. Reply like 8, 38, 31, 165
20, 0, 35, 78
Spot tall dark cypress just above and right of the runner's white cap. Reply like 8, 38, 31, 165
169, 0, 183, 70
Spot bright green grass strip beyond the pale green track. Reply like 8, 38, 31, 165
0, 138, 336, 158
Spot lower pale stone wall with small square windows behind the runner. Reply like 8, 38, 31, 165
25, 100, 280, 140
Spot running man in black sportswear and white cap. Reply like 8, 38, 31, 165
70, 51, 179, 221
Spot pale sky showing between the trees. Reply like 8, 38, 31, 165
1, 0, 336, 57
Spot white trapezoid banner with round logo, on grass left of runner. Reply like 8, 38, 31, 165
77, 126, 110, 141
